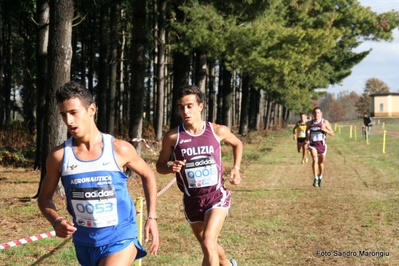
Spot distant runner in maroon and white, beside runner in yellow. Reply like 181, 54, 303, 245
306, 107, 334, 187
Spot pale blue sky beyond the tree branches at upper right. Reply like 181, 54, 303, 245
327, 0, 399, 95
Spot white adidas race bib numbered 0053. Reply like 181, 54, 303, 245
70, 186, 118, 228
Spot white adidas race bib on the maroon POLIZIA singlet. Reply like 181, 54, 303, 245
185, 156, 219, 188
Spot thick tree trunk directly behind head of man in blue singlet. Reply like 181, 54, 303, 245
39, 0, 74, 194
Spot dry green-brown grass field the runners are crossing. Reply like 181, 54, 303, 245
0, 124, 399, 266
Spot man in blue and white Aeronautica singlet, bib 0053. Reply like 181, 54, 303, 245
38, 81, 159, 266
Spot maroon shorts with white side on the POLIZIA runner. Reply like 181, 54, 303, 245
183, 188, 231, 223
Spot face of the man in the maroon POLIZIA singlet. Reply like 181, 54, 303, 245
177, 94, 203, 125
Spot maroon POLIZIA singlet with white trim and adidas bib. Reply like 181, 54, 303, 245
173, 122, 224, 196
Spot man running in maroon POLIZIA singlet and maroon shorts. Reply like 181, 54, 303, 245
156, 86, 243, 266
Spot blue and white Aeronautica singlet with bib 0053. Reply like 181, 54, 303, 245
61, 134, 138, 247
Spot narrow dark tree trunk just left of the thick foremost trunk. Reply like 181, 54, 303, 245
34, 0, 50, 169
